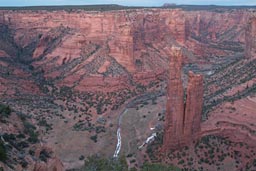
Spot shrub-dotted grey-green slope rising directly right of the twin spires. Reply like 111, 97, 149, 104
203, 59, 256, 120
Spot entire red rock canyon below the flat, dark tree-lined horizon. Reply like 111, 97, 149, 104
0, 6, 256, 171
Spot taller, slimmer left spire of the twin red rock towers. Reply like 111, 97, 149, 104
163, 48, 184, 150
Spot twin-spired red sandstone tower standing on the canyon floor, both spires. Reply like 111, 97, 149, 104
163, 48, 203, 151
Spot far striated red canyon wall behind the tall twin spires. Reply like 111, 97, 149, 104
0, 9, 251, 90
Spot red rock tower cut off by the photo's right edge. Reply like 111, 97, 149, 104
245, 17, 256, 59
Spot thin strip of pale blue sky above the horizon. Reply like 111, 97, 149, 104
0, 0, 256, 6
